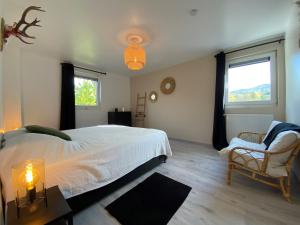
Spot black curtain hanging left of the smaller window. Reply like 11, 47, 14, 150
60, 63, 75, 130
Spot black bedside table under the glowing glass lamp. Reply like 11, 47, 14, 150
7, 186, 73, 225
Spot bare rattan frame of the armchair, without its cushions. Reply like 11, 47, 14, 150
227, 132, 300, 202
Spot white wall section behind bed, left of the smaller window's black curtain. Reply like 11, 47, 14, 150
20, 51, 61, 128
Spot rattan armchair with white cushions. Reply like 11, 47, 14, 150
220, 131, 300, 202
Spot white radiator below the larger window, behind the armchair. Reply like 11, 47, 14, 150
226, 114, 274, 141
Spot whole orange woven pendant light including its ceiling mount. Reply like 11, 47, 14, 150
124, 35, 146, 70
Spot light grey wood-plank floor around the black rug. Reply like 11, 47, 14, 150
74, 140, 300, 225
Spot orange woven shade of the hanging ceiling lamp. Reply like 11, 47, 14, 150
124, 44, 146, 70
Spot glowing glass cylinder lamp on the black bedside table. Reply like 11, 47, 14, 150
12, 159, 46, 208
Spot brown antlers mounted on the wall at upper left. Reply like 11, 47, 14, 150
4, 6, 45, 44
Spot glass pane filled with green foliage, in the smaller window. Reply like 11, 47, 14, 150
74, 77, 98, 106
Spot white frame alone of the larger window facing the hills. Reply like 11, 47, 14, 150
224, 51, 278, 108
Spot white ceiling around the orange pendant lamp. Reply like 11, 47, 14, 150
5, 0, 292, 76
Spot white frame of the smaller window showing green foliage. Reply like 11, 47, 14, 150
74, 70, 101, 110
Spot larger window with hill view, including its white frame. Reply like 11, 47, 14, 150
225, 53, 276, 105
